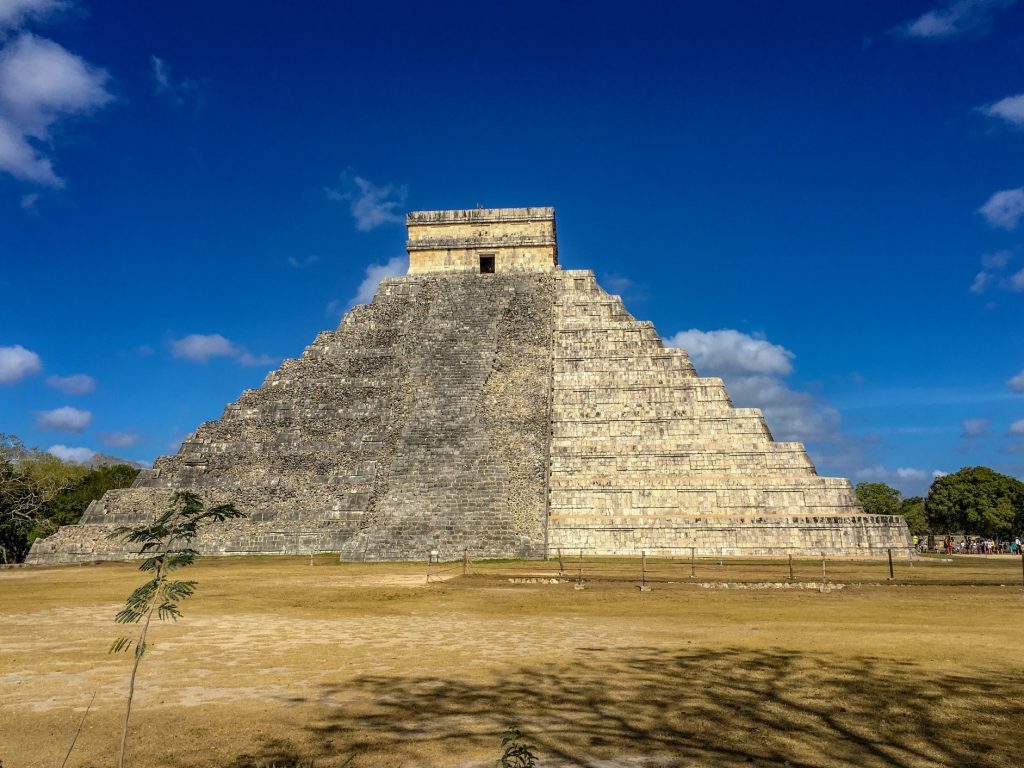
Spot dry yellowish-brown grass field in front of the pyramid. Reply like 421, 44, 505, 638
0, 556, 1024, 768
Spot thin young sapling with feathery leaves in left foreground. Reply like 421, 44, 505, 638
111, 492, 246, 768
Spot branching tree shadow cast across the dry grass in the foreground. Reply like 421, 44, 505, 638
233, 648, 1024, 768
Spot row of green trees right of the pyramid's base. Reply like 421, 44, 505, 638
856, 467, 1024, 540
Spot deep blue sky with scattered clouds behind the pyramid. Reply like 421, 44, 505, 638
0, 0, 1024, 493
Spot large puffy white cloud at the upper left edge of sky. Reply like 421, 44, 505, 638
0, 33, 114, 187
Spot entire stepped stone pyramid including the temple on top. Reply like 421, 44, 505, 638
29, 208, 910, 563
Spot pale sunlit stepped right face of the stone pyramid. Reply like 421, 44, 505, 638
548, 271, 910, 556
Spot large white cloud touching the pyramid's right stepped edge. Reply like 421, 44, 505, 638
666, 329, 840, 440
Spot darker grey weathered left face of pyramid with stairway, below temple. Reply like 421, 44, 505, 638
30, 274, 552, 562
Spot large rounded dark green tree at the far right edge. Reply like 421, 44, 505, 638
925, 467, 1024, 538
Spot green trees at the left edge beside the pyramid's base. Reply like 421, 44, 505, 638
0, 433, 138, 563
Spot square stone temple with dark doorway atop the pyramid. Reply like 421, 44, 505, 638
406, 208, 558, 274
